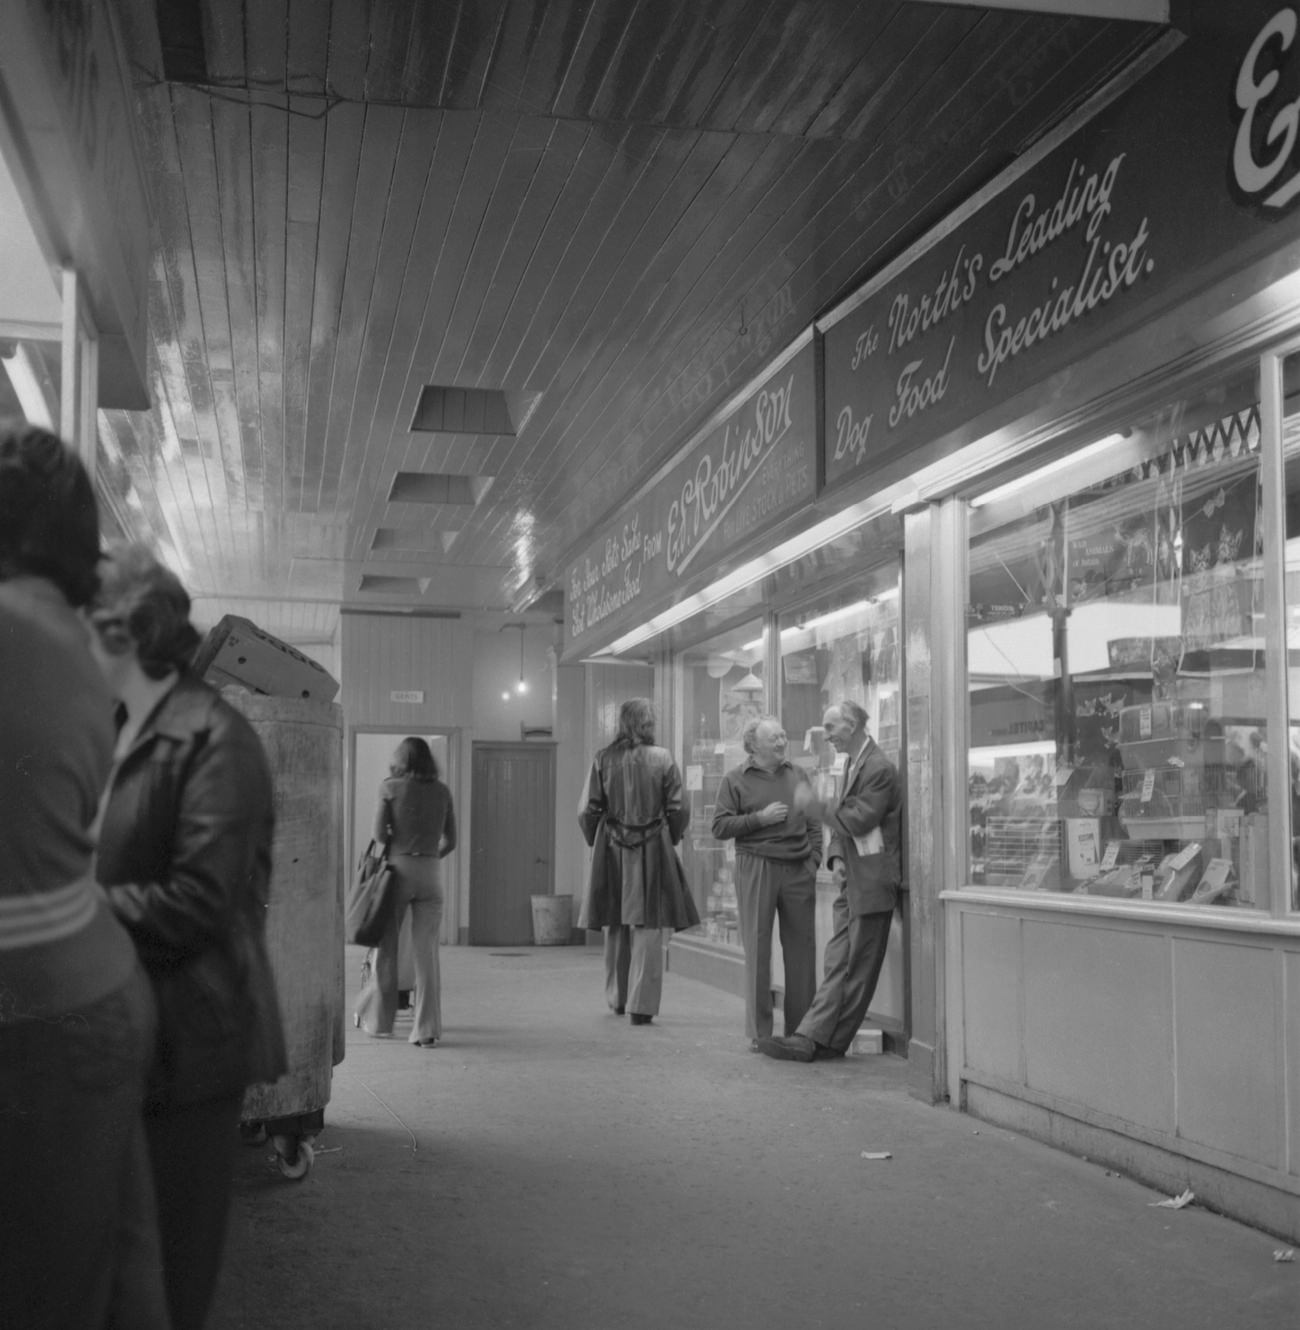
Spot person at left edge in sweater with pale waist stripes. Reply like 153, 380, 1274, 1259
0, 430, 166, 1330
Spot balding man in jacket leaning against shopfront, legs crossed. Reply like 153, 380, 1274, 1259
758, 701, 902, 1063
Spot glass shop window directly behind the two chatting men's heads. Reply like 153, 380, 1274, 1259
780, 563, 902, 799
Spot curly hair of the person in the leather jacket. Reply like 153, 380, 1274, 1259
90, 545, 201, 678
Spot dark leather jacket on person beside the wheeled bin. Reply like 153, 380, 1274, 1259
97, 674, 286, 1108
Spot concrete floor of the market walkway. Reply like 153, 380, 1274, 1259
209, 947, 1300, 1330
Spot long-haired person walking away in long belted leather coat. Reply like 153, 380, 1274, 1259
577, 697, 700, 1025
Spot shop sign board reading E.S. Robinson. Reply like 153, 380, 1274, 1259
564, 342, 817, 648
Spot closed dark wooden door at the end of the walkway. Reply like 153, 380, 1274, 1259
470, 743, 555, 947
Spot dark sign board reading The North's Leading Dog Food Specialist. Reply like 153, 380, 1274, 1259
824, 0, 1300, 485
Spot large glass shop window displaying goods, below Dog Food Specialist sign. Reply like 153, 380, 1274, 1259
967, 368, 1266, 908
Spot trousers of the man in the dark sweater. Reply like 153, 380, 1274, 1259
736, 851, 817, 1039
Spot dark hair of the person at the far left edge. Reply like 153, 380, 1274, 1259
0, 426, 100, 606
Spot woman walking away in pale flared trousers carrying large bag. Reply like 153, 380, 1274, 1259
357, 737, 456, 1048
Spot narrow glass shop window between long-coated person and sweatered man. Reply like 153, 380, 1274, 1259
677, 620, 769, 947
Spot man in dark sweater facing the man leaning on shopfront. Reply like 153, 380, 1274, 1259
713, 716, 821, 1049
